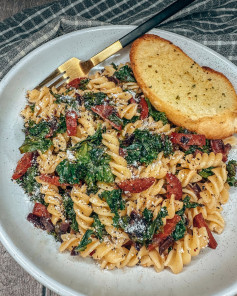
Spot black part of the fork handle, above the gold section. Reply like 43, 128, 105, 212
119, 0, 195, 47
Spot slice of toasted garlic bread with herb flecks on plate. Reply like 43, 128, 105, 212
130, 34, 237, 139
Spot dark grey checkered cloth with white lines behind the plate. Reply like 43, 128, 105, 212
0, 0, 237, 79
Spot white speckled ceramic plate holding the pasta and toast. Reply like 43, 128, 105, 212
0, 26, 237, 296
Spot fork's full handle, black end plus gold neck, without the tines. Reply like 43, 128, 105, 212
88, 0, 195, 69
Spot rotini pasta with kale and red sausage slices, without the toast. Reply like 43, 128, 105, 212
12, 63, 237, 273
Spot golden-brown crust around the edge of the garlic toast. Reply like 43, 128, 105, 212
130, 34, 237, 139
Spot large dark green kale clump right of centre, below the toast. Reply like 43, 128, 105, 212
124, 129, 173, 165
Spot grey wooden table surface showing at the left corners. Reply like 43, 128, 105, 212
0, 0, 61, 296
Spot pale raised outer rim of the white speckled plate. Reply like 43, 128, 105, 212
0, 25, 237, 296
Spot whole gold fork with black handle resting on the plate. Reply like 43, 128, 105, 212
36, 0, 195, 89
